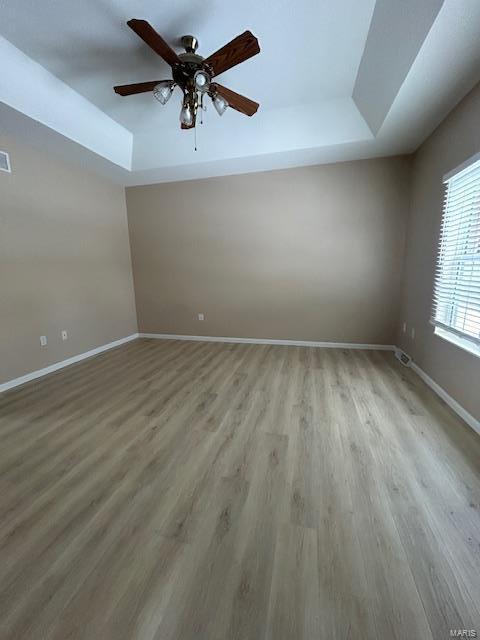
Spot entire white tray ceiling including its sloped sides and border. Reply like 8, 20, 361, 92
0, 0, 480, 184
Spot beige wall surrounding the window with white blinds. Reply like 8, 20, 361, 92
398, 85, 480, 419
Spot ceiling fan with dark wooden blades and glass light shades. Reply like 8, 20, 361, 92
113, 19, 260, 129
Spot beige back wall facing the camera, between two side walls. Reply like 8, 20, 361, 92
127, 158, 410, 344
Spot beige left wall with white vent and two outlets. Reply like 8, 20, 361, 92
0, 135, 136, 383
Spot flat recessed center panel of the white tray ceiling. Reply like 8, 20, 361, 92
0, 0, 375, 132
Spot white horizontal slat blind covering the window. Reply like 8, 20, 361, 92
432, 155, 480, 344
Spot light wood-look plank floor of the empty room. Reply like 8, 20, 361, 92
0, 340, 480, 640
